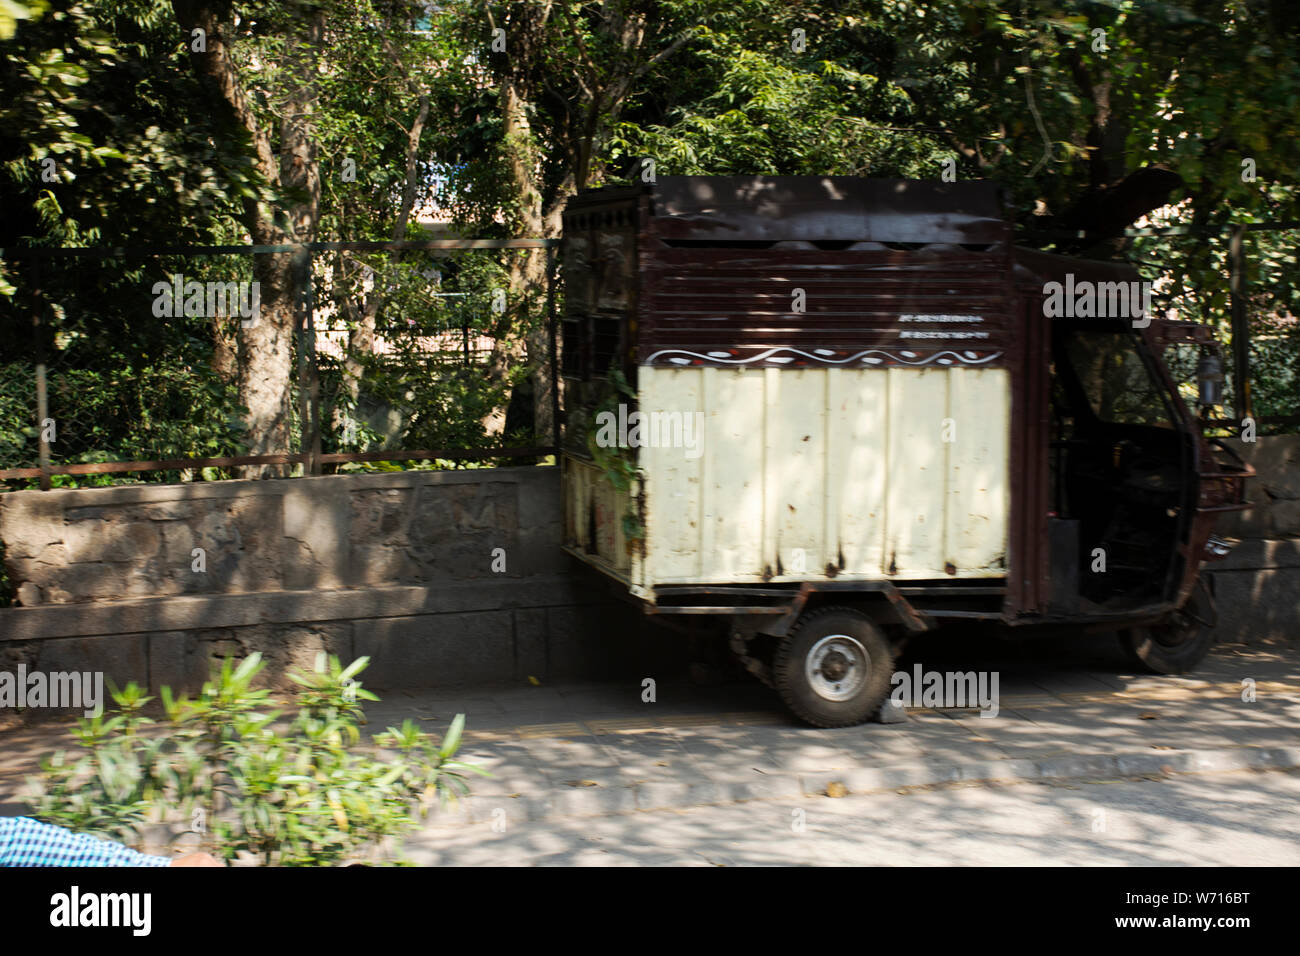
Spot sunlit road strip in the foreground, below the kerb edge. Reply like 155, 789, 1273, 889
407, 771, 1300, 866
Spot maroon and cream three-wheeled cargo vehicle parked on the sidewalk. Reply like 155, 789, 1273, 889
562, 177, 1251, 727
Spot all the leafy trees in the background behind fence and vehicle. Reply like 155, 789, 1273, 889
0, 0, 1300, 486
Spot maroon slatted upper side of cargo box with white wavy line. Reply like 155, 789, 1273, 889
636, 247, 1015, 368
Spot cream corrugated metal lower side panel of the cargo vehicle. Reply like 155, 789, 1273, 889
640, 367, 1010, 585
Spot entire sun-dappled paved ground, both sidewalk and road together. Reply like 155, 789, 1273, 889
0, 640, 1300, 866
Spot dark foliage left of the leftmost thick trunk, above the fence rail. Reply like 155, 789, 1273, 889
0, 0, 261, 252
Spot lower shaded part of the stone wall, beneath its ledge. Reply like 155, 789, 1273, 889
0, 575, 702, 693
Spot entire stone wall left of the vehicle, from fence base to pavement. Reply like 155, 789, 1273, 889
0, 467, 685, 689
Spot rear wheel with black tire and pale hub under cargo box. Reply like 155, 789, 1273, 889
772, 607, 893, 727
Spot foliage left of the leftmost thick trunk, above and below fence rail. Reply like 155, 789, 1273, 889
0, 0, 261, 486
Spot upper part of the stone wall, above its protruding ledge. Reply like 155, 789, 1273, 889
0, 468, 560, 607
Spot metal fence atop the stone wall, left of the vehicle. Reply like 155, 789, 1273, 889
0, 239, 558, 488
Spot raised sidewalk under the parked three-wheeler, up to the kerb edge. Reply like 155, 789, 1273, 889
0, 637, 1300, 848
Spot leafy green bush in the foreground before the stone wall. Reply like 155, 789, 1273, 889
33, 653, 486, 866
